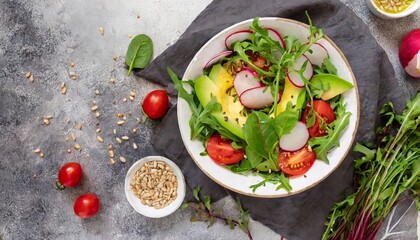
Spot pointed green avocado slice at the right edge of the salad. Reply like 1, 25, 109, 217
311, 74, 354, 101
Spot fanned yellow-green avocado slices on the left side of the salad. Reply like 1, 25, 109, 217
194, 64, 246, 139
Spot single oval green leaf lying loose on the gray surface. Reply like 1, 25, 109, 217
125, 34, 153, 76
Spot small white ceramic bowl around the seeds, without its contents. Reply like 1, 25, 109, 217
124, 156, 185, 218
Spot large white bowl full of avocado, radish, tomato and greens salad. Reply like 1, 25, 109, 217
168, 17, 359, 197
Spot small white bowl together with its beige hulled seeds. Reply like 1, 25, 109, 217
124, 156, 185, 218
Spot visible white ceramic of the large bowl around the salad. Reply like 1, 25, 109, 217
177, 18, 360, 198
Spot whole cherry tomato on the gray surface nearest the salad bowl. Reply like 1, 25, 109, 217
142, 90, 169, 119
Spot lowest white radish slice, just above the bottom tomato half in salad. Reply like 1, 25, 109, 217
279, 122, 309, 151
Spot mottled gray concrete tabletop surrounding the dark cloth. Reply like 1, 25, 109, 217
0, 0, 420, 239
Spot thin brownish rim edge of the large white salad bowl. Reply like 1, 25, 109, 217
177, 17, 360, 198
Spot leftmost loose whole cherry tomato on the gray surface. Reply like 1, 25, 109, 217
57, 162, 83, 187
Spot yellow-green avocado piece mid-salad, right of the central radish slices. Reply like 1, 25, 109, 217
276, 77, 306, 115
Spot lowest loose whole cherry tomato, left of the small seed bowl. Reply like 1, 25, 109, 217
74, 193, 100, 218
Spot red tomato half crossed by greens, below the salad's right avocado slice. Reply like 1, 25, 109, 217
302, 100, 335, 137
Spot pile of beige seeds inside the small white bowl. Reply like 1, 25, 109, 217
130, 161, 178, 209
